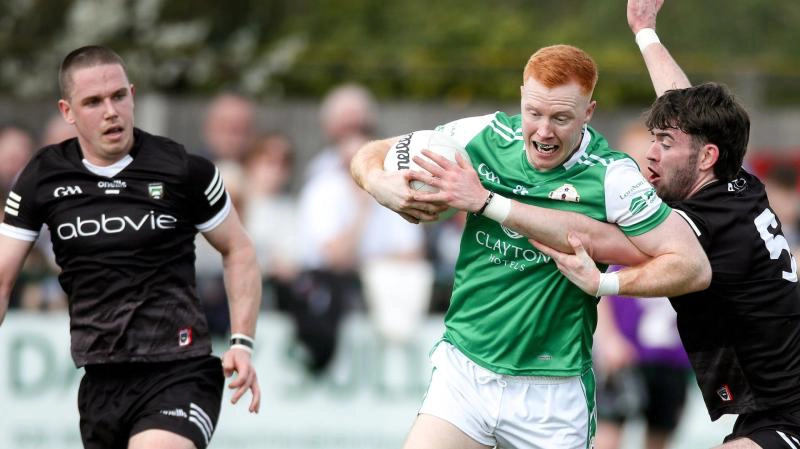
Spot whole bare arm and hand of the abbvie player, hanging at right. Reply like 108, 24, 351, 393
203, 210, 261, 413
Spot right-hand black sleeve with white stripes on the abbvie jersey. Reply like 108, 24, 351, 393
189, 155, 232, 232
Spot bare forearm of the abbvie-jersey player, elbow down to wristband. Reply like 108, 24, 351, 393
223, 245, 261, 337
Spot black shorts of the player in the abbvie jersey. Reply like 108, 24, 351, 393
78, 356, 225, 449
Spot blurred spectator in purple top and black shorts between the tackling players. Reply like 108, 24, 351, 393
594, 122, 692, 449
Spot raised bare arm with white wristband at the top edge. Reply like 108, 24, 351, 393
628, 0, 692, 97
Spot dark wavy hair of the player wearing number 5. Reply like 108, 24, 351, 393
645, 83, 750, 182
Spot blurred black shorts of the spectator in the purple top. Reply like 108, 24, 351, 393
597, 363, 691, 433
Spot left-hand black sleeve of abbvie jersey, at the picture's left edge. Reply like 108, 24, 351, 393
3, 159, 43, 241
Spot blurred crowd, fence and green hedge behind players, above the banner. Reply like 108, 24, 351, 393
0, 0, 800, 447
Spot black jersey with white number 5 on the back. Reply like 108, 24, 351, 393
670, 170, 800, 420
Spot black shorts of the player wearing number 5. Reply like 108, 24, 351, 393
725, 407, 800, 449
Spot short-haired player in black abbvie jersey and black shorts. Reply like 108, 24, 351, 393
0, 46, 261, 449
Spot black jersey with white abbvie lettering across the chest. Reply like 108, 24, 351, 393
0, 129, 231, 366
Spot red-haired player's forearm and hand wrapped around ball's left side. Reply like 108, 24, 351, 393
350, 137, 447, 223
